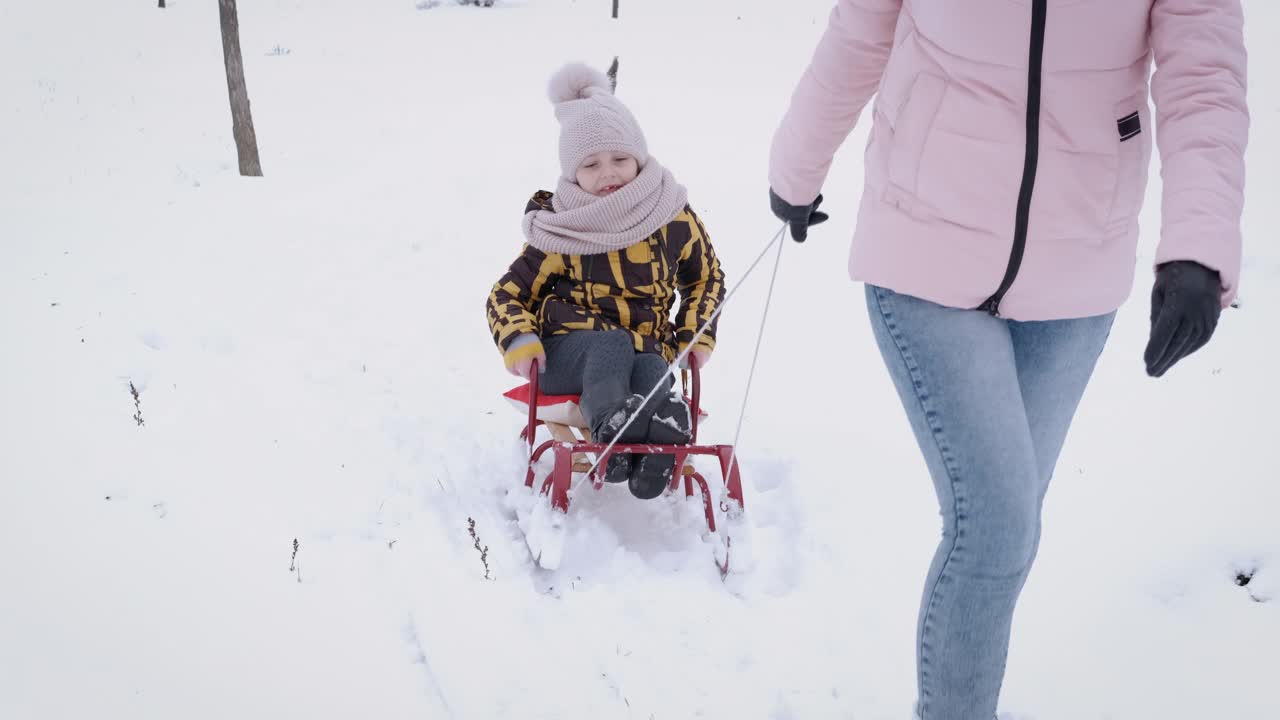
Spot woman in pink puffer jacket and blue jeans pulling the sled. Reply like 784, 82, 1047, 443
769, 0, 1248, 720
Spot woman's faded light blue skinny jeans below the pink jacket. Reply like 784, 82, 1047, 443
867, 284, 1115, 720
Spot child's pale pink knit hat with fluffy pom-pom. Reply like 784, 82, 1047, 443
548, 63, 649, 181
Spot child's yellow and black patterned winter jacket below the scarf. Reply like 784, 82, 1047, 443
485, 191, 724, 363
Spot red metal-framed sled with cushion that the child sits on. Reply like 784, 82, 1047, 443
504, 354, 745, 577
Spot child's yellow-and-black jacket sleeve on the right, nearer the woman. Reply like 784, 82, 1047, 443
676, 208, 724, 352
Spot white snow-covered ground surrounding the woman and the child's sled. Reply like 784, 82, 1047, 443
0, 0, 1280, 720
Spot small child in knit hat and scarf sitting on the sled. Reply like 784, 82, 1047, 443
486, 64, 724, 500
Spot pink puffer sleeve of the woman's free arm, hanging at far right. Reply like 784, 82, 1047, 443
1151, 0, 1249, 307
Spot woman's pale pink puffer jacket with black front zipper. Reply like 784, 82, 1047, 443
769, 0, 1249, 320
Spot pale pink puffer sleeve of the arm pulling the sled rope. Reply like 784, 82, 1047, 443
769, 0, 902, 205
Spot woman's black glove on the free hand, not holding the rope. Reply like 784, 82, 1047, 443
1143, 260, 1222, 378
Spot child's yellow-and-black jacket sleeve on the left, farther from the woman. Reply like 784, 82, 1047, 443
485, 245, 564, 354
